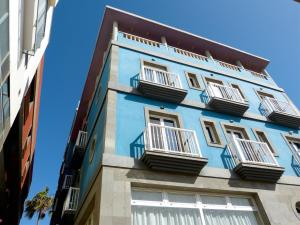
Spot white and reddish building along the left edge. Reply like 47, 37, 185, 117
0, 0, 57, 225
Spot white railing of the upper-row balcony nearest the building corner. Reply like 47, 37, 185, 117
140, 66, 182, 89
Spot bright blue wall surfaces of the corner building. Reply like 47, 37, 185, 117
76, 31, 300, 200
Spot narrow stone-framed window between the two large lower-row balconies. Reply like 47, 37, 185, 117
201, 120, 224, 148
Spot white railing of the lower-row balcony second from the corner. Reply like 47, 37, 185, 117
229, 137, 279, 166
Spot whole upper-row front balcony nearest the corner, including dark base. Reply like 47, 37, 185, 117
138, 66, 187, 103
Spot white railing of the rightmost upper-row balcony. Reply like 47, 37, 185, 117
261, 97, 299, 116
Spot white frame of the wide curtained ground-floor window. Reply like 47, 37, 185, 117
131, 188, 264, 225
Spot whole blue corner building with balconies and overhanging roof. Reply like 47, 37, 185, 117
51, 7, 300, 225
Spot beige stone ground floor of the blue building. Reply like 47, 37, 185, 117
74, 154, 300, 225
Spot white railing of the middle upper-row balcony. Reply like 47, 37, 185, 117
206, 83, 246, 103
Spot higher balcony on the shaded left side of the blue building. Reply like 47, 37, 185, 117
71, 131, 87, 169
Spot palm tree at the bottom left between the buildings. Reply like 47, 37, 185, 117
25, 187, 53, 225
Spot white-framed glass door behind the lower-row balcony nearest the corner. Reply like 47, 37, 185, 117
150, 116, 183, 152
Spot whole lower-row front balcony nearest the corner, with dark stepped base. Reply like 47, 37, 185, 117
141, 123, 207, 175
